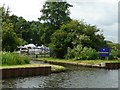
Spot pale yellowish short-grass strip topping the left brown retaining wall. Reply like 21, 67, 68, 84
0, 64, 65, 72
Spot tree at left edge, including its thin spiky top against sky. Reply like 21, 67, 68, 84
0, 6, 23, 52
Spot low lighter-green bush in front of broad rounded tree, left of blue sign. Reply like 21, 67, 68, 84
66, 45, 99, 60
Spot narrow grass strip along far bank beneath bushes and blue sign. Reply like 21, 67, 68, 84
37, 58, 120, 65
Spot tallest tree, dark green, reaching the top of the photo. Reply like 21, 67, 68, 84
39, 0, 72, 44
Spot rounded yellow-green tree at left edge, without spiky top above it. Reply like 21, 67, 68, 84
2, 22, 19, 52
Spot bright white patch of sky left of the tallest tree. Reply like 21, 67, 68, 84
0, 0, 44, 21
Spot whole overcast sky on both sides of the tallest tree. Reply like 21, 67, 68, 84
0, 0, 119, 43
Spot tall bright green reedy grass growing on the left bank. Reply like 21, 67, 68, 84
2, 52, 30, 65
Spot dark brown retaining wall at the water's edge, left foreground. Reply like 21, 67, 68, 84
0, 66, 51, 79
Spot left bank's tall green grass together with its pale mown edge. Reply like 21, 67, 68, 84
0, 52, 65, 72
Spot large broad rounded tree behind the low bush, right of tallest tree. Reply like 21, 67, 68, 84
51, 20, 106, 57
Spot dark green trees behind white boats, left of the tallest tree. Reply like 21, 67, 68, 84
10, 15, 43, 45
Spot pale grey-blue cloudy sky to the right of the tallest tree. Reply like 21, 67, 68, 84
70, 2, 118, 42
